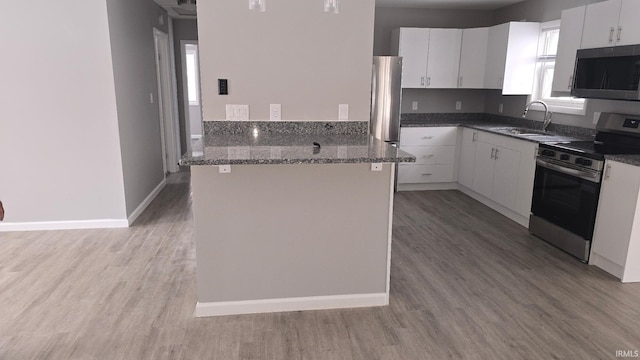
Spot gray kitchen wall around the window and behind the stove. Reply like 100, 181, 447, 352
485, 0, 640, 128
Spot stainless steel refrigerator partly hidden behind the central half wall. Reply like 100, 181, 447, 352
369, 56, 402, 143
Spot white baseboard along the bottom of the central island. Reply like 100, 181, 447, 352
195, 293, 389, 317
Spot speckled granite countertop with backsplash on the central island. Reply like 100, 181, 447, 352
180, 122, 415, 166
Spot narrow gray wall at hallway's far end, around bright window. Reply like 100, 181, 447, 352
173, 19, 202, 154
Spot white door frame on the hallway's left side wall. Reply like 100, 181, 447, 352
153, 28, 180, 174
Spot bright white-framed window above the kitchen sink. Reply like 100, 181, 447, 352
531, 21, 585, 115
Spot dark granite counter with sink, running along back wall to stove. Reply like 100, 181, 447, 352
400, 113, 595, 143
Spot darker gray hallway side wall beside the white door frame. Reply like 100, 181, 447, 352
107, 0, 168, 216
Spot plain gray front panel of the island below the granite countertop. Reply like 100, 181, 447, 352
191, 164, 391, 303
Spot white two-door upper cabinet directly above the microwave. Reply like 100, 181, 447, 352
581, 0, 640, 49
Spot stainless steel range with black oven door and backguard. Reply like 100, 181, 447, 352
529, 113, 640, 262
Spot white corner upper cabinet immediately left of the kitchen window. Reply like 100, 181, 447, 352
485, 22, 540, 95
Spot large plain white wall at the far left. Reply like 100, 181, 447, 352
0, 0, 126, 225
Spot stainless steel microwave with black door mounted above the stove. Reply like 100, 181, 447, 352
571, 45, 640, 101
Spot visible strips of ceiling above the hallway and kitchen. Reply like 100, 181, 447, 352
153, 0, 524, 19
